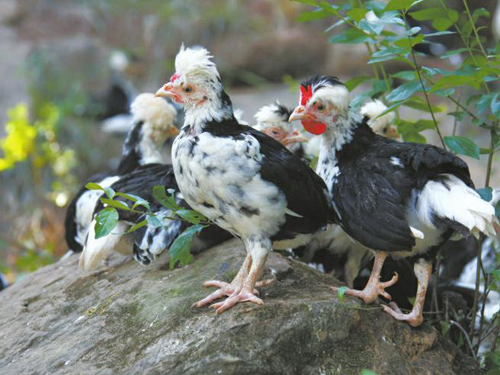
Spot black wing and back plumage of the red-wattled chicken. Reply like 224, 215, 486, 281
333, 123, 473, 251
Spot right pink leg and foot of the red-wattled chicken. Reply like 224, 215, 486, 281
382, 259, 432, 327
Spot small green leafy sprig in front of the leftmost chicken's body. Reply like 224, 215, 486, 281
90, 182, 209, 268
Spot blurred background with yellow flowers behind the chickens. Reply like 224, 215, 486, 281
0, 0, 500, 282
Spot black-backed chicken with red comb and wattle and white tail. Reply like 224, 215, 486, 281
290, 76, 496, 326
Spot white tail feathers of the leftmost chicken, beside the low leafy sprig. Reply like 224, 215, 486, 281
78, 220, 132, 271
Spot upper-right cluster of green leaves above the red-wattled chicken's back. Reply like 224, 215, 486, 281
298, 0, 500, 158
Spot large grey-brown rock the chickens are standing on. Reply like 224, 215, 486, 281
0, 240, 480, 375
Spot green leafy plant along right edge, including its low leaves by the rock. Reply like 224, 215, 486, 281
292, 0, 500, 375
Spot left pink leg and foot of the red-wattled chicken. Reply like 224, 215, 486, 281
332, 251, 398, 303
